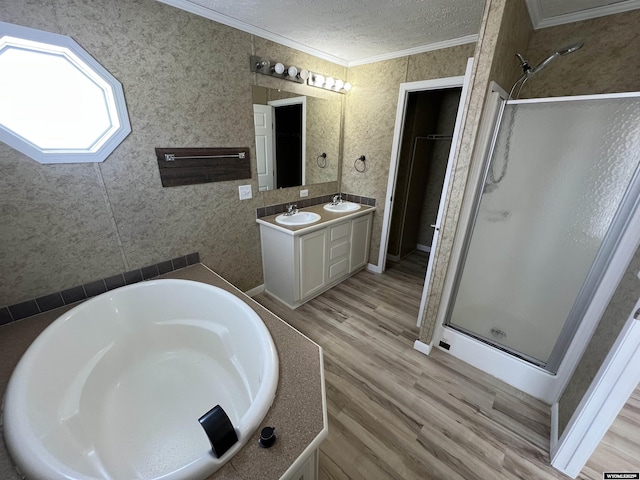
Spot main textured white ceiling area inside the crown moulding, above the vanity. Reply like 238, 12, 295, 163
192, 0, 484, 60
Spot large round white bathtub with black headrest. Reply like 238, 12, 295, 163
3, 280, 278, 480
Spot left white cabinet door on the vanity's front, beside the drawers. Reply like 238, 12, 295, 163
298, 228, 327, 300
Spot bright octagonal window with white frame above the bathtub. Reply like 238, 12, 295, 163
0, 22, 131, 163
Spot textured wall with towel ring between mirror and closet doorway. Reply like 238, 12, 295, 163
341, 44, 475, 265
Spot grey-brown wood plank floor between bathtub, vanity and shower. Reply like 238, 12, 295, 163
255, 253, 576, 480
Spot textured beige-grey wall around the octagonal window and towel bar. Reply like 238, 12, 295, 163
0, 0, 345, 305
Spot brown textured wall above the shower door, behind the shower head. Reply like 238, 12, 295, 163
520, 10, 640, 98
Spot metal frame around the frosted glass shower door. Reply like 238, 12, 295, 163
443, 92, 640, 375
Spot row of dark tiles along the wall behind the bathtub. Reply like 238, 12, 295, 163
0, 252, 200, 325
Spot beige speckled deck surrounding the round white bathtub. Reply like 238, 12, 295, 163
0, 264, 328, 480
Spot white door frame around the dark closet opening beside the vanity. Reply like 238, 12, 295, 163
372, 58, 473, 282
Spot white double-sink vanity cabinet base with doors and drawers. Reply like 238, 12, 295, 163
258, 209, 373, 308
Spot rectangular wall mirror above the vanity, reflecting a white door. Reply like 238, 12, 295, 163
253, 86, 342, 191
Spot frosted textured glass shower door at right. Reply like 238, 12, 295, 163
445, 95, 640, 371
